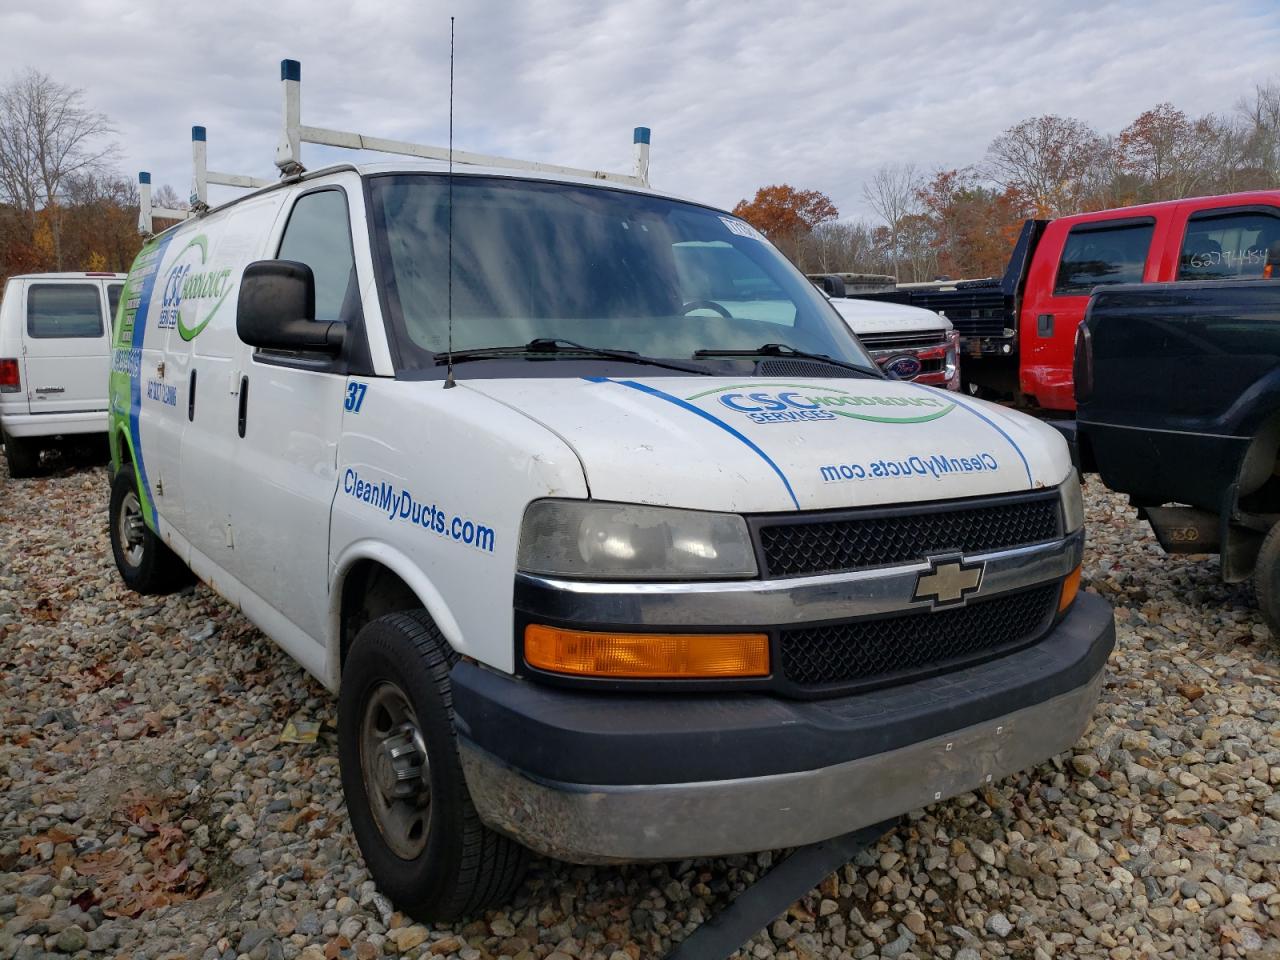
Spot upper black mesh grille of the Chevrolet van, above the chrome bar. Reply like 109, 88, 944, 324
755, 493, 1061, 577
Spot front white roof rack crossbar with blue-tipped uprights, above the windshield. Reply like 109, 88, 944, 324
275, 60, 650, 187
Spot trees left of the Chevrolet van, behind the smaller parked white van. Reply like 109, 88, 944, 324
0, 69, 186, 285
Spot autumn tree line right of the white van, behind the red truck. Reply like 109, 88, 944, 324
733, 81, 1280, 283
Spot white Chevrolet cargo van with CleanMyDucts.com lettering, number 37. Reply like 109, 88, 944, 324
110, 161, 1114, 919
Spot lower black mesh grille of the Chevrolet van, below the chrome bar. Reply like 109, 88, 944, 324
781, 582, 1059, 687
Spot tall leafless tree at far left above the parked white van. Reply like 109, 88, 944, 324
0, 69, 115, 270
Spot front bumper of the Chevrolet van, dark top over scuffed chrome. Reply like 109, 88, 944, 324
452, 594, 1115, 863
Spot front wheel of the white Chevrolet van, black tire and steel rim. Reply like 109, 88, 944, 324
338, 611, 529, 922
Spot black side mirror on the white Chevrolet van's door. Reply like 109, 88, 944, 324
236, 260, 346, 353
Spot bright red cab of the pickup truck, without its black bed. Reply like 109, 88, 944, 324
1018, 191, 1280, 411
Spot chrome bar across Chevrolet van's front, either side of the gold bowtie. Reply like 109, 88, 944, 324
516, 531, 1084, 627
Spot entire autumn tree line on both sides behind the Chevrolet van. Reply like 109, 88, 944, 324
0, 69, 1280, 289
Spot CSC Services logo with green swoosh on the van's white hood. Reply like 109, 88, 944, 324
687, 383, 956, 424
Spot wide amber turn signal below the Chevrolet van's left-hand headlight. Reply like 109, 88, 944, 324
525, 623, 769, 680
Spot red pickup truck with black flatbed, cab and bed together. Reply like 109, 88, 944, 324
854, 191, 1280, 412
